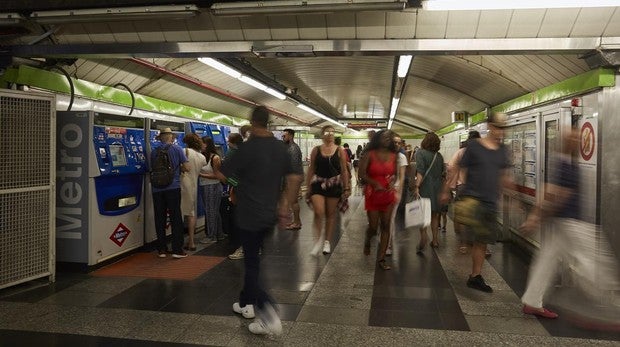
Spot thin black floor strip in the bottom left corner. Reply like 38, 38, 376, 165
0, 330, 204, 347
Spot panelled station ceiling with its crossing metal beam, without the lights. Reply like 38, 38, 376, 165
0, 2, 620, 135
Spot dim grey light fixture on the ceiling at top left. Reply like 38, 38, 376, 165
30, 5, 200, 24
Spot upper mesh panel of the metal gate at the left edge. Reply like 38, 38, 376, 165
0, 96, 52, 189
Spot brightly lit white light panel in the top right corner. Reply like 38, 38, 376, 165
422, 0, 620, 11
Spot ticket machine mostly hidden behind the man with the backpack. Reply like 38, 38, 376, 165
144, 119, 186, 243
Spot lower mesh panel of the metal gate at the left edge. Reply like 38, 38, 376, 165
0, 190, 50, 288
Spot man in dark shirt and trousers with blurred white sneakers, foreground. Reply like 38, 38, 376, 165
221, 106, 300, 335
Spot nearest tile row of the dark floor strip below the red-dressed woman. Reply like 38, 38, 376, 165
368, 310, 446, 330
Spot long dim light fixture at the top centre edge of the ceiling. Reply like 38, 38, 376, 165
211, 0, 407, 16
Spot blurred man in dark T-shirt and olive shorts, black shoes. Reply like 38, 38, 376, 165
441, 113, 512, 293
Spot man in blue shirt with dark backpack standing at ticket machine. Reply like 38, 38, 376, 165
151, 128, 190, 259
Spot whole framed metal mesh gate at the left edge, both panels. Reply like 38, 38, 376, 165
0, 90, 56, 288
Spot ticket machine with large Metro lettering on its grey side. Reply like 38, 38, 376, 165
56, 111, 146, 266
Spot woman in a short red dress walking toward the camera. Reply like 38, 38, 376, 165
359, 130, 397, 270
